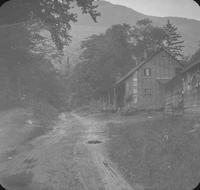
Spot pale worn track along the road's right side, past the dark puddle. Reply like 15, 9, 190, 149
73, 114, 133, 190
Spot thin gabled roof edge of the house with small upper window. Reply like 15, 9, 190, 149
115, 47, 182, 85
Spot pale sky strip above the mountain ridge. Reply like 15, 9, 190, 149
106, 0, 200, 20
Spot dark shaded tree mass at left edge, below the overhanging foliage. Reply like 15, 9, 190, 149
0, 21, 66, 108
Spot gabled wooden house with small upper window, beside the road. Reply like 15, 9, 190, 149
115, 48, 181, 110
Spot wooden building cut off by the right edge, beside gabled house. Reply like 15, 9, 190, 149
166, 50, 200, 116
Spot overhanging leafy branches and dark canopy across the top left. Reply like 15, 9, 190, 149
0, 0, 99, 50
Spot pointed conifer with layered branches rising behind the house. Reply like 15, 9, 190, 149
163, 20, 184, 59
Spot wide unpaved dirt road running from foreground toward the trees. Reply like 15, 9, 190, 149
0, 113, 132, 190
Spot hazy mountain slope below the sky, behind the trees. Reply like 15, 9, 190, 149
63, 1, 200, 66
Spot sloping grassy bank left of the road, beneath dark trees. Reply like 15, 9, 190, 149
0, 104, 57, 162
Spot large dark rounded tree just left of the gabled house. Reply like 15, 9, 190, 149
71, 24, 135, 105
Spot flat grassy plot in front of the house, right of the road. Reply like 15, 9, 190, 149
108, 115, 200, 190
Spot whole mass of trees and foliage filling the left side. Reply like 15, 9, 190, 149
0, 0, 99, 124
